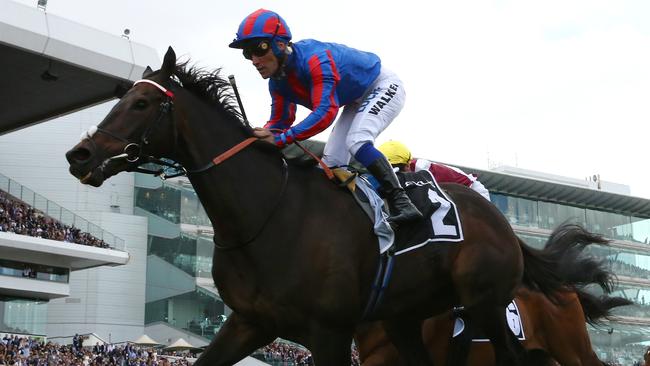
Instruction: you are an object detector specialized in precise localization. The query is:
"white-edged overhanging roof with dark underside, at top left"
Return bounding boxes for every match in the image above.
[0,0,160,134]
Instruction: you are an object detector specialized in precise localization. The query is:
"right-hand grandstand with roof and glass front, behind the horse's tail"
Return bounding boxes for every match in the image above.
[461,167,650,365]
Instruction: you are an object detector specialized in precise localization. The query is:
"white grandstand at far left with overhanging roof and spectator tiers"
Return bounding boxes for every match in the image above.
[0,0,159,348]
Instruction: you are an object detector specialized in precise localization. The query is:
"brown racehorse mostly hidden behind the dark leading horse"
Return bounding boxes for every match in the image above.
[355,225,632,366]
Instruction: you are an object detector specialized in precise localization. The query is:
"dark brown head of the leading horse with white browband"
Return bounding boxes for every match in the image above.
[66,47,176,187]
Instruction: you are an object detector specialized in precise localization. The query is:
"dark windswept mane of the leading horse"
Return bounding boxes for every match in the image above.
[168,60,252,132]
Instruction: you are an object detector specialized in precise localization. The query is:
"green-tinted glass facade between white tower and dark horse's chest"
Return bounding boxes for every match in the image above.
[135,177,226,338]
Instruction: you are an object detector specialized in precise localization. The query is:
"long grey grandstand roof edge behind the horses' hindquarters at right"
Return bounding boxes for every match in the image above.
[459,167,650,218]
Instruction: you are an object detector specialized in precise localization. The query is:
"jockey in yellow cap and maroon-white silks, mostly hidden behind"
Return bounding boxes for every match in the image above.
[379,141,490,201]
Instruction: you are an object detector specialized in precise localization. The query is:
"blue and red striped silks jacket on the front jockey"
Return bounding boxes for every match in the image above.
[264,39,381,145]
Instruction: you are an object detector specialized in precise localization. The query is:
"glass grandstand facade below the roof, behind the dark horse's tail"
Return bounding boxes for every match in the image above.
[490,193,650,365]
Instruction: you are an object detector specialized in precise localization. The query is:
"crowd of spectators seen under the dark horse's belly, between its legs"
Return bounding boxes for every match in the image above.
[253,341,361,366]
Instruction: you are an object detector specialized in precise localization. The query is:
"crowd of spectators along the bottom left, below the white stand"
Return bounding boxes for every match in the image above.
[0,335,190,366]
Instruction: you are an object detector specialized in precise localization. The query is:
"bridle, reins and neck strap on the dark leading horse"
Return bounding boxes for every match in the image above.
[81,79,289,250]
